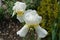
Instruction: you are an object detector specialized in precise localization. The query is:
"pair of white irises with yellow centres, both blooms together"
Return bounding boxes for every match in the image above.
[13,2,48,38]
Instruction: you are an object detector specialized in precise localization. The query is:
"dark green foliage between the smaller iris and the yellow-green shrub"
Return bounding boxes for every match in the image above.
[23,0,40,10]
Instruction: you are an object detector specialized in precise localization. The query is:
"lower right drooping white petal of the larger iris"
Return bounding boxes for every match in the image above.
[35,26,48,38]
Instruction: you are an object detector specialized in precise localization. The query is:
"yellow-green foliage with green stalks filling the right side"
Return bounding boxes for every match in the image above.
[37,0,58,40]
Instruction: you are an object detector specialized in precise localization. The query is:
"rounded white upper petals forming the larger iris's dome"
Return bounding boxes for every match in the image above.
[24,10,42,24]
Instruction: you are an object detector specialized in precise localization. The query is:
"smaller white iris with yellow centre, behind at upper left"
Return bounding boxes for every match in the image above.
[12,2,26,22]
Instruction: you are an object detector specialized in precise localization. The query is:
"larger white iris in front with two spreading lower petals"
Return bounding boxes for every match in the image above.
[17,10,48,38]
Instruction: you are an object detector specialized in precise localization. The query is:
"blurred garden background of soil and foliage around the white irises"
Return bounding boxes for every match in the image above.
[0,0,60,40]
